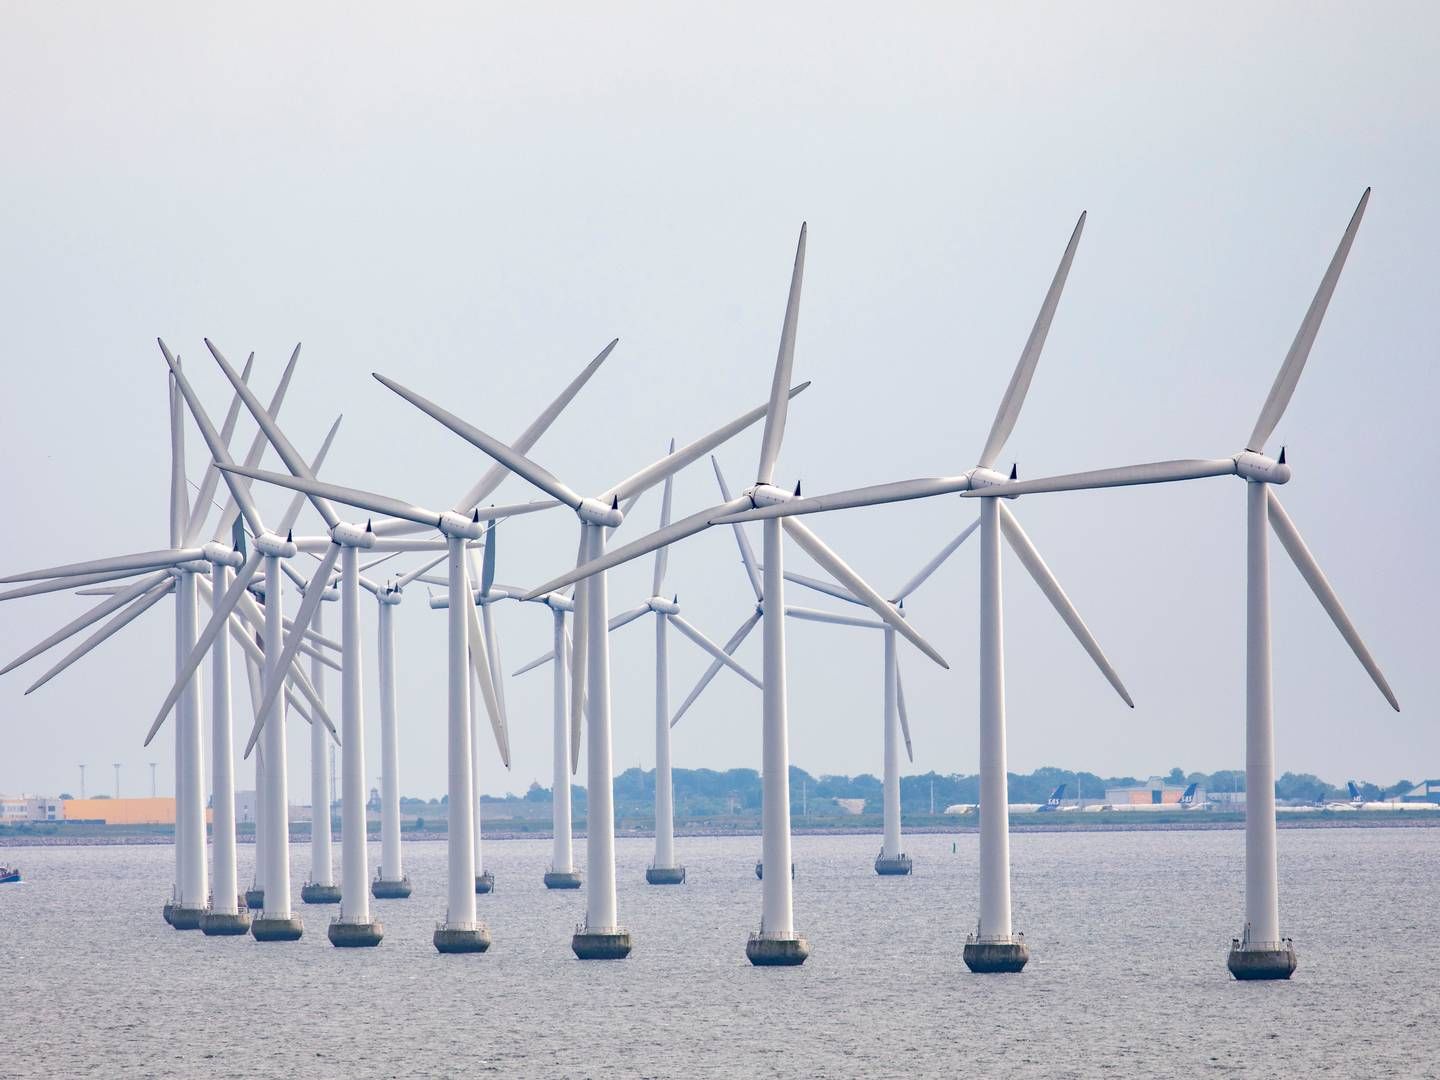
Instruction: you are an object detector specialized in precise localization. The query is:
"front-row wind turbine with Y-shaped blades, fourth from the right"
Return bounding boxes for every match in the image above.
[365,364,805,959]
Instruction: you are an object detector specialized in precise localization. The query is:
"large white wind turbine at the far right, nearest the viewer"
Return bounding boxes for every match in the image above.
[976,187,1400,979]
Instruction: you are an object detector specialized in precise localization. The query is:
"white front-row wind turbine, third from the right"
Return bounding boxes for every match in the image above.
[526,225,948,966]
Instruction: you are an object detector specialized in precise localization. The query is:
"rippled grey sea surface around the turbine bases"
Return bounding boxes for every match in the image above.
[0,828,1440,1080]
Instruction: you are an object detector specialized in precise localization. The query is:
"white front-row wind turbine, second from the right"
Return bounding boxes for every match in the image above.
[604,213,1133,972]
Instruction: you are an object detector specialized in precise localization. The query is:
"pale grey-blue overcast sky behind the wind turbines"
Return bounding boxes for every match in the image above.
[0,1,1440,802]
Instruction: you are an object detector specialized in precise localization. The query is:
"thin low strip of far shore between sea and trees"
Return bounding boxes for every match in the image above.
[0,811,1440,850]
